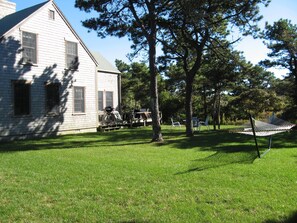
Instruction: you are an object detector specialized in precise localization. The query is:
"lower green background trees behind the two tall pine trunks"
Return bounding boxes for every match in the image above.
[116,42,296,128]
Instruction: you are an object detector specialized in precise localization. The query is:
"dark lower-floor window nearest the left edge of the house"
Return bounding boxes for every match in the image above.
[13,81,31,115]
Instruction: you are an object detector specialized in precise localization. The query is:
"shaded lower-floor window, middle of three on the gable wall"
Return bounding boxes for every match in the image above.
[45,83,60,115]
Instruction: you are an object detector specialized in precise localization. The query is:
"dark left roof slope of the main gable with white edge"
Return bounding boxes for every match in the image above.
[0,2,48,37]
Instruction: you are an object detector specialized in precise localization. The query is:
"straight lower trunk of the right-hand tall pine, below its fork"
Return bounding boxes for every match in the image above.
[185,74,194,137]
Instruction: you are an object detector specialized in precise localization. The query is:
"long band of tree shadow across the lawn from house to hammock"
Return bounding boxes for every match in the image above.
[0,127,296,159]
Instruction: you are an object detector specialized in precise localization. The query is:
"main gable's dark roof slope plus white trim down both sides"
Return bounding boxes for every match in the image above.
[0,0,98,65]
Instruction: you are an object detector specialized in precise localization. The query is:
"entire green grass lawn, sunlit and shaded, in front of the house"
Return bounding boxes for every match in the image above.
[0,126,297,223]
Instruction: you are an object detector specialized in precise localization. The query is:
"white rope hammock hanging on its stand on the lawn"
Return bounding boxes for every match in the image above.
[237,115,295,158]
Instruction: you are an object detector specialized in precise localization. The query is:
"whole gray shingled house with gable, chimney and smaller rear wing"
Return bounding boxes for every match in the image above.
[0,0,120,141]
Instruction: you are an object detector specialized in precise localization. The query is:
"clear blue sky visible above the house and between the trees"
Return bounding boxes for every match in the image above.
[10,0,297,77]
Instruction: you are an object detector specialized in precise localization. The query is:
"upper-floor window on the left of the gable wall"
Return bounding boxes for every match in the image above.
[22,32,37,64]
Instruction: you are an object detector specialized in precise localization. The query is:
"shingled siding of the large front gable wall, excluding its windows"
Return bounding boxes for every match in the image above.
[0,3,97,140]
